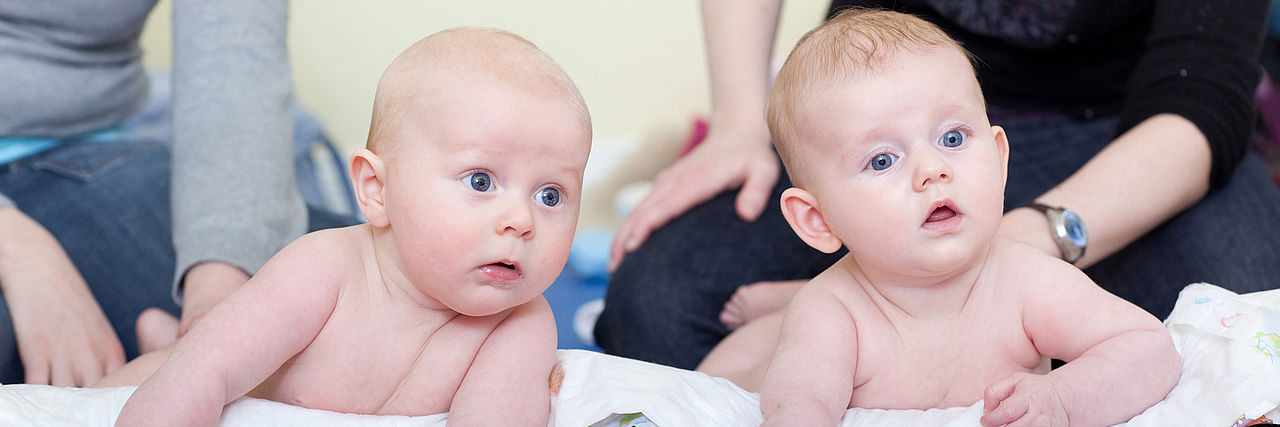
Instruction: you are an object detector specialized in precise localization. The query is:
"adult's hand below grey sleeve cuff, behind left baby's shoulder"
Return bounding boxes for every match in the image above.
[178,261,248,336]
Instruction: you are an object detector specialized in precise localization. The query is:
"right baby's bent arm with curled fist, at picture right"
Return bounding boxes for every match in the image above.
[982,260,1181,426]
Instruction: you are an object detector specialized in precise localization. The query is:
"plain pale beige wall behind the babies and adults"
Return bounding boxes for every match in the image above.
[135,0,827,230]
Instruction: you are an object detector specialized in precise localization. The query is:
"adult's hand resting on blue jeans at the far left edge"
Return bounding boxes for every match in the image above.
[0,207,124,386]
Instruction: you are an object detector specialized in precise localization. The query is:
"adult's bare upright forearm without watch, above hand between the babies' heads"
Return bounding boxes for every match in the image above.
[701,0,782,136]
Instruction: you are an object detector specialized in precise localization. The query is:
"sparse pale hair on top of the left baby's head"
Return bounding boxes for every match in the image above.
[366,27,591,153]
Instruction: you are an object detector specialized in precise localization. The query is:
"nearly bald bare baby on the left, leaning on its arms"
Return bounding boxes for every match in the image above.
[110,28,591,427]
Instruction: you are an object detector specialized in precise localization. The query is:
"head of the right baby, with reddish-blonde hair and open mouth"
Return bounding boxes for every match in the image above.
[767,9,1009,274]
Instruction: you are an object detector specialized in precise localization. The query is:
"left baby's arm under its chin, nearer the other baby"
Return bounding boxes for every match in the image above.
[449,297,556,427]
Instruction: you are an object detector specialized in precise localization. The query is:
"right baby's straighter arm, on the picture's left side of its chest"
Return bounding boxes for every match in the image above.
[760,283,858,426]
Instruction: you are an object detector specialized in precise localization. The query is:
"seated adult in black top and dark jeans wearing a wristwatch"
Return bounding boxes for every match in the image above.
[595,0,1280,368]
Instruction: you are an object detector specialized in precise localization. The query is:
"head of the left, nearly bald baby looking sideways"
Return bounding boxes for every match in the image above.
[351,28,591,316]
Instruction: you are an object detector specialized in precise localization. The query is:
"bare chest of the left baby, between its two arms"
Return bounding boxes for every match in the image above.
[247,315,489,415]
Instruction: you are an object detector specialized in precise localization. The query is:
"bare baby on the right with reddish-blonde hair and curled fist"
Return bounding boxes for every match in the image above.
[700,9,1180,426]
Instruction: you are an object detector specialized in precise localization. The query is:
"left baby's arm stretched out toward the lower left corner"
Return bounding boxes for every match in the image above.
[116,237,342,426]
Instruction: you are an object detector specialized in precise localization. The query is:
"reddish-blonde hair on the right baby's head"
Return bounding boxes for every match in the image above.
[765,8,973,185]
